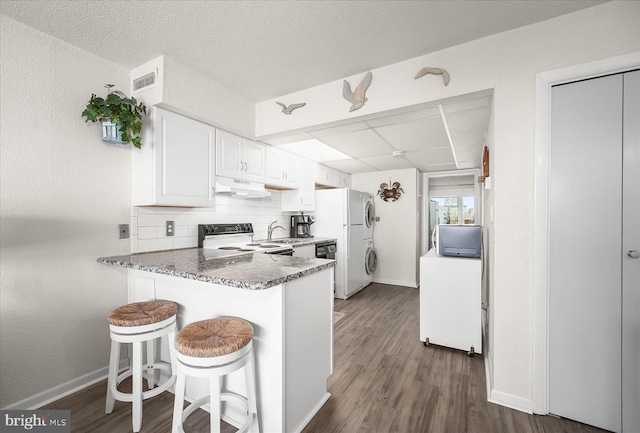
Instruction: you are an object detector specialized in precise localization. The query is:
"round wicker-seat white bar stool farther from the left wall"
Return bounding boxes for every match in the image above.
[172,317,260,433]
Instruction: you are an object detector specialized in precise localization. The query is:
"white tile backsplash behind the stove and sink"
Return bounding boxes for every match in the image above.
[131,191,291,253]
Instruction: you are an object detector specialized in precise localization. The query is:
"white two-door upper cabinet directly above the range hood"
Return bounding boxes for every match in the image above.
[216,129,265,183]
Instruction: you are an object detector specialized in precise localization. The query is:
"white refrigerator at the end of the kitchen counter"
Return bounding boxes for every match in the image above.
[313,188,366,299]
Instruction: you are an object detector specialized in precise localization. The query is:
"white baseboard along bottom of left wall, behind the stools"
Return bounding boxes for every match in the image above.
[2,359,129,410]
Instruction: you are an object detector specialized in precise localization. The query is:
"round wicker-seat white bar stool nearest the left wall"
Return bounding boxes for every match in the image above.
[105,300,178,432]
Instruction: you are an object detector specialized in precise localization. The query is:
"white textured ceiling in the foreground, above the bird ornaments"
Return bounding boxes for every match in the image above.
[0,0,603,102]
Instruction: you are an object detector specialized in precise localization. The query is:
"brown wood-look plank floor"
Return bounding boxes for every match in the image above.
[44,283,604,433]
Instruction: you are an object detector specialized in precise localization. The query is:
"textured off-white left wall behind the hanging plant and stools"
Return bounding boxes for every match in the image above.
[0,16,131,407]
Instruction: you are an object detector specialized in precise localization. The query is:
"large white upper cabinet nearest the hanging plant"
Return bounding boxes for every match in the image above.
[131,107,216,207]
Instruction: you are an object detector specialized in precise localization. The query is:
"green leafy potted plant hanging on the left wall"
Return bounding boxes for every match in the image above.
[82,84,147,149]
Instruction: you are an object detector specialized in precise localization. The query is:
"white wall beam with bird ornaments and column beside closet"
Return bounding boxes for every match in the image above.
[256,1,640,411]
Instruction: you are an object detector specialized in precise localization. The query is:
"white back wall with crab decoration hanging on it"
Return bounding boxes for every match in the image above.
[351,168,420,287]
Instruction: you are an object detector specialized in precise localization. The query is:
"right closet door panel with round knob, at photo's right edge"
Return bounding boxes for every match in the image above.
[622,71,640,433]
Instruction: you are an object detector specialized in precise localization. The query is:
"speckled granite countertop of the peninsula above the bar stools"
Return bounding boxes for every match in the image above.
[98,248,335,290]
